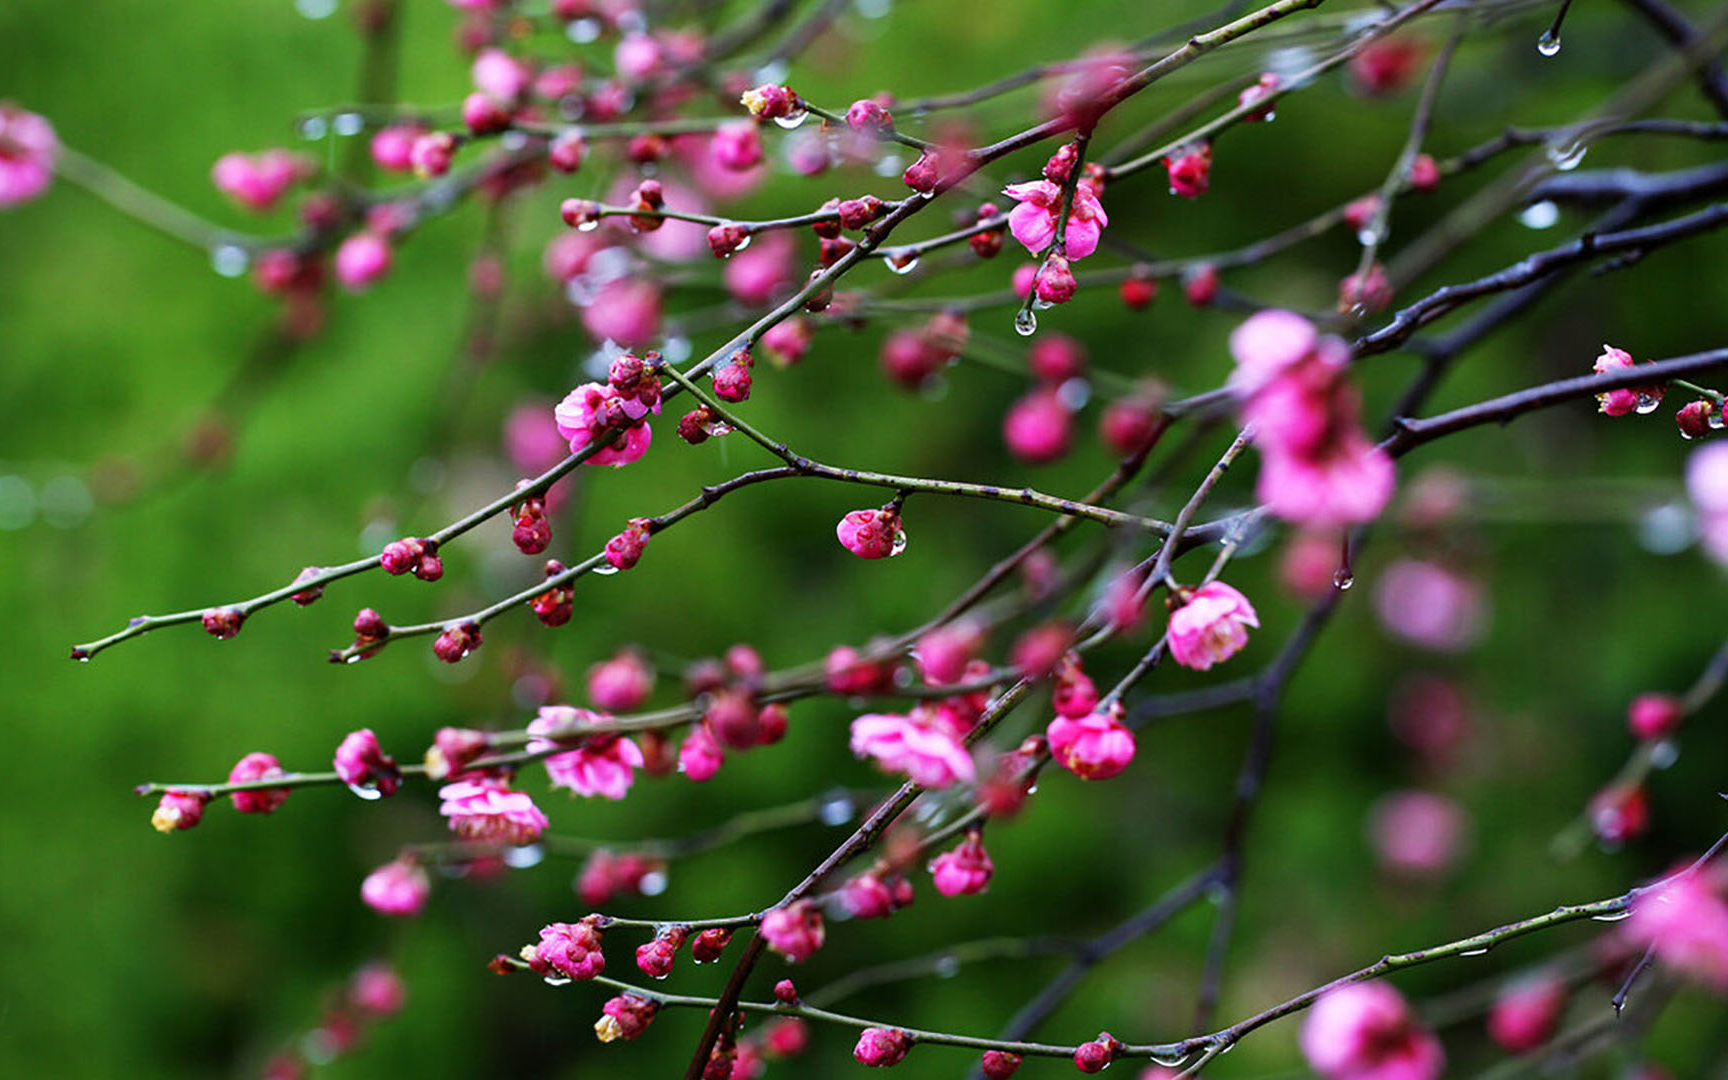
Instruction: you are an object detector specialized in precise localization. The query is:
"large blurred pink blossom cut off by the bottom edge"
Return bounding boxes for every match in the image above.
[1301,983,1446,1080]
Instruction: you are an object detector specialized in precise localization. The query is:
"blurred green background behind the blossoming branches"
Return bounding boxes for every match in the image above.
[0,0,1728,1080]
